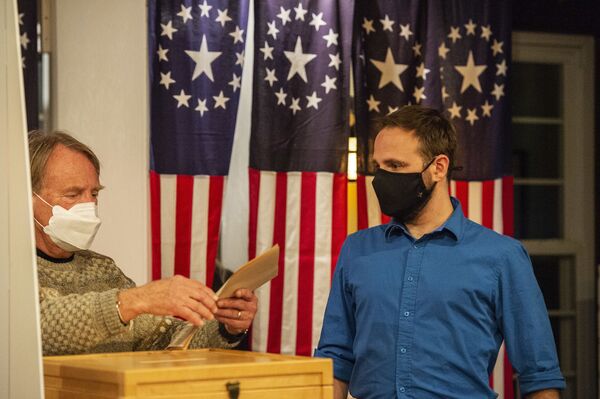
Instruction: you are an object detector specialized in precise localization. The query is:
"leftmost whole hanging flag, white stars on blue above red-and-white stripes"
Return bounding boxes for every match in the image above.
[148,0,249,287]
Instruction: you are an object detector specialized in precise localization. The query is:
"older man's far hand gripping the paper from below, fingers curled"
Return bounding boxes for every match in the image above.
[215,288,258,335]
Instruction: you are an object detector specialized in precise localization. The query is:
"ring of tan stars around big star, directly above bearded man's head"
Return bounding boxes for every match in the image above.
[360,9,439,117]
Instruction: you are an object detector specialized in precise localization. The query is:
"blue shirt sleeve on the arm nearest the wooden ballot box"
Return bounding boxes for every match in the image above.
[314,241,355,382]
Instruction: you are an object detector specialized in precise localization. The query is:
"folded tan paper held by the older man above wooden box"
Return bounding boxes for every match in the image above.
[167,245,279,350]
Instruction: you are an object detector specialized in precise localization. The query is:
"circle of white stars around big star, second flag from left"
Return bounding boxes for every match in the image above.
[256,1,342,119]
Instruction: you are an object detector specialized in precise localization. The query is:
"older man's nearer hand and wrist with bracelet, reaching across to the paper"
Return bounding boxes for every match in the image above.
[119,276,218,326]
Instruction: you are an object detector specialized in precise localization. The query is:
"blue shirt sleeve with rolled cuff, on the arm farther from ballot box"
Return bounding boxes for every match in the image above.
[496,241,565,394]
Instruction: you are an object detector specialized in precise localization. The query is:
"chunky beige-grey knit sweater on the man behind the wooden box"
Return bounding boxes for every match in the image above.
[37,251,238,355]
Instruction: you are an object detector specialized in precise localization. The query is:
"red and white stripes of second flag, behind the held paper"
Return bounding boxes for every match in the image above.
[248,169,347,355]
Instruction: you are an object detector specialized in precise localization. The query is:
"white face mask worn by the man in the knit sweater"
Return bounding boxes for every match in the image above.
[34,193,102,252]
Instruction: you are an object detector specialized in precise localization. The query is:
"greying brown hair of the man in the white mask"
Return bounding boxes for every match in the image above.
[28,130,100,192]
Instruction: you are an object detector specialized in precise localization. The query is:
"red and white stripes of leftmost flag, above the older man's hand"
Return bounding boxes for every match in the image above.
[150,171,225,287]
